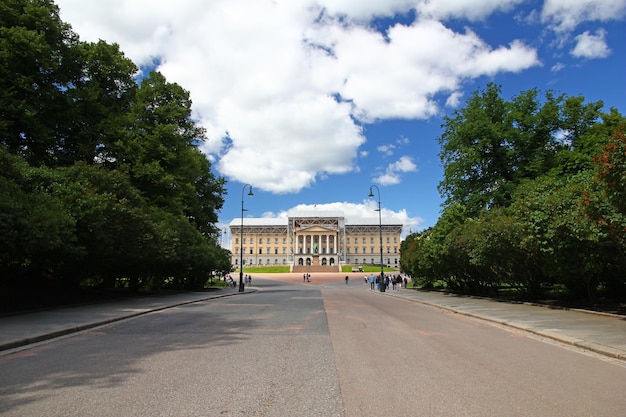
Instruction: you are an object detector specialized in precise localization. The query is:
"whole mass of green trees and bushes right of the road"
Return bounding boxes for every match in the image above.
[401,84,626,300]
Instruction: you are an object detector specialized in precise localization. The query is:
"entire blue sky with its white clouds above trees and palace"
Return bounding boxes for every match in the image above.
[57,0,626,244]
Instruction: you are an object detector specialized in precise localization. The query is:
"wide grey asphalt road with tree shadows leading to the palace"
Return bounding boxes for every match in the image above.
[0,278,626,417]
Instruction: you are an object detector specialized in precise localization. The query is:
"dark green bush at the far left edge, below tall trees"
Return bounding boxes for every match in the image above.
[0,146,83,301]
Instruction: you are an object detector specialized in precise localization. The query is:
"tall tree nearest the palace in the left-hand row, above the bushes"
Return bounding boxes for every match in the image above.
[111,72,224,218]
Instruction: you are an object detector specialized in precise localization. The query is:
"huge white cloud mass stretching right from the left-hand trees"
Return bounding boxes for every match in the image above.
[57,0,539,193]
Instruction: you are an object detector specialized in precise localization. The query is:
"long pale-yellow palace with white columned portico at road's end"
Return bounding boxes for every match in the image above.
[230,211,402,271]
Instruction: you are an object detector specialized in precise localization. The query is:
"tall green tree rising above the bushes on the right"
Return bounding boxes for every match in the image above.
[439,83,602,215]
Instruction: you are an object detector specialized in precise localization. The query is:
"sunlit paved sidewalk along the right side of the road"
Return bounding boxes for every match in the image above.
[381,289,626,361]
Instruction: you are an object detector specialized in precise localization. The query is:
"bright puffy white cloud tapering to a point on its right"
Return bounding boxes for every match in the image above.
[312,20,539,122]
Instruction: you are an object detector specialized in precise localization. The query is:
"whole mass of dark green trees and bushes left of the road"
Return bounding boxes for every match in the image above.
[0,0,230,302]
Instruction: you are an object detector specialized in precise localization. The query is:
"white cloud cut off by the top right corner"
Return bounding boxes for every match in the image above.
[541,0,626,32]
